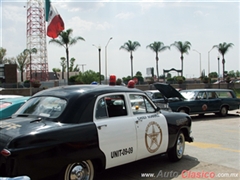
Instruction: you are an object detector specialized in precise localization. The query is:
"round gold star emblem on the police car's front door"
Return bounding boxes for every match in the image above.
[145,121,162,153]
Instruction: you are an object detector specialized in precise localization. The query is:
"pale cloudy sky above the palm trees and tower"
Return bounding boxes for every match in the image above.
[0,0,240,78]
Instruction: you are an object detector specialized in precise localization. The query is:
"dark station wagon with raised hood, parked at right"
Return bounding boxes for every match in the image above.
[154,83,240,116]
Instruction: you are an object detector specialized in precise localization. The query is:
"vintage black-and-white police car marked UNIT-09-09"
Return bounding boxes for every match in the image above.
[0,85,193,180]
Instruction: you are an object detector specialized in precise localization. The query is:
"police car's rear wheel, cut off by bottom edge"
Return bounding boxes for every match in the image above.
[64,160,94,180]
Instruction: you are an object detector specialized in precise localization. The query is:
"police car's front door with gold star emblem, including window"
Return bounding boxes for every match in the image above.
[128,93,168,159]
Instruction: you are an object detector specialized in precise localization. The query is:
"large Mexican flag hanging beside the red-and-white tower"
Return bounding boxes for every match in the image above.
[45,0,64,39]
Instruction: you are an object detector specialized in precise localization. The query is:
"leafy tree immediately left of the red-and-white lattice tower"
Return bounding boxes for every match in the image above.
[15,51,29,82]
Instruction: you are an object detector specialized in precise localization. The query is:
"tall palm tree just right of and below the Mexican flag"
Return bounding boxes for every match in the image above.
[49,29,85,84]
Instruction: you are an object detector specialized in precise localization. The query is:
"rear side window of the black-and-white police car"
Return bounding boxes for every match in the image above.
[95,95,127,119]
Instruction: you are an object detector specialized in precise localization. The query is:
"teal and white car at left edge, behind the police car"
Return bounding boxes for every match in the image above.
[0,96,31,120]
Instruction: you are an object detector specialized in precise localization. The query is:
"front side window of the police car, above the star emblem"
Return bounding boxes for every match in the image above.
[129,94,155,114]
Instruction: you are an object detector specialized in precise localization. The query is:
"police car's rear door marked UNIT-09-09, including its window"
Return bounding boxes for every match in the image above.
[94,93,137,168]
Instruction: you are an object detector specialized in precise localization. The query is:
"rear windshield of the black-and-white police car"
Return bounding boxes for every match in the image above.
[15,96,67,118]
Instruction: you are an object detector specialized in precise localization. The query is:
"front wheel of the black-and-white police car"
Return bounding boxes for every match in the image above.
[168,131,185,161]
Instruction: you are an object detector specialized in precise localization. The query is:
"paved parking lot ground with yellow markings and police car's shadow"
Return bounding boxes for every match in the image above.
[95,111,240,180]
